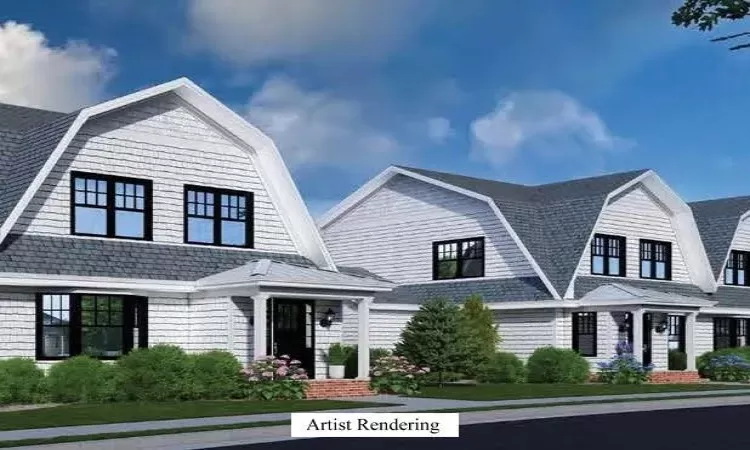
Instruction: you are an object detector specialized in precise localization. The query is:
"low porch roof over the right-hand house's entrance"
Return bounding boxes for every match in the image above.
[579,283,716,308]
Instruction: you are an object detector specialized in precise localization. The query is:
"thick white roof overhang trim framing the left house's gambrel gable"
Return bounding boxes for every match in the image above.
[0,78,336,270]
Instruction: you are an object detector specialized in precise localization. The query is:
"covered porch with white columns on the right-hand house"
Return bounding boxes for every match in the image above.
[577,283,716,372]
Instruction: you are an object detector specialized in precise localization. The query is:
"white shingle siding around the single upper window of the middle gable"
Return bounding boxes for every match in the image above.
[323,175,536,283]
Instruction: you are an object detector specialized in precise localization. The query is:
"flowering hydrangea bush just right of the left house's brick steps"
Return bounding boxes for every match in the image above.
[370,356,430,395]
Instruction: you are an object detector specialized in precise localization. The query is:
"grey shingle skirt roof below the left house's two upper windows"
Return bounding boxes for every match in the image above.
[0,234,314,281]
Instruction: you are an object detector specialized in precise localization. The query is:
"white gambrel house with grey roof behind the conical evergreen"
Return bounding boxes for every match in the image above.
[320,167,750,371]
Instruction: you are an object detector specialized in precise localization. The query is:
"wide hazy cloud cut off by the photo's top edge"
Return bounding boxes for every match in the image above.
[187,0,432,65]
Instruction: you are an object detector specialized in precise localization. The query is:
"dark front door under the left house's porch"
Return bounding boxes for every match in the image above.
[268,298,315,378]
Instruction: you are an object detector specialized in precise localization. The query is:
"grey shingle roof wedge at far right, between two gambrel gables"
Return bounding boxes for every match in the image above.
[689,196,750,278]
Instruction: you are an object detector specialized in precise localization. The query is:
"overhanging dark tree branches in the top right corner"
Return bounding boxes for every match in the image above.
[672,0,750,50]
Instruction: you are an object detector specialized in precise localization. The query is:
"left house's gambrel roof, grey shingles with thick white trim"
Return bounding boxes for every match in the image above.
[0,78,336,278]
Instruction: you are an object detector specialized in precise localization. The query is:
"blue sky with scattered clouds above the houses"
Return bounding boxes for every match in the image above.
[0,0,750,216]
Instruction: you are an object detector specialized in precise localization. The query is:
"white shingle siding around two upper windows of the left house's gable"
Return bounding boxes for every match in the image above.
[15,92,295,252]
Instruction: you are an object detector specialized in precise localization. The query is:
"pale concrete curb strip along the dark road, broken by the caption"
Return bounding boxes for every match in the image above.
[16,395,750,450]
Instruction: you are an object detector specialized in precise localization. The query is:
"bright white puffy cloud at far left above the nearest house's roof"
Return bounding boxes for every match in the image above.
[0,22,116,111]
